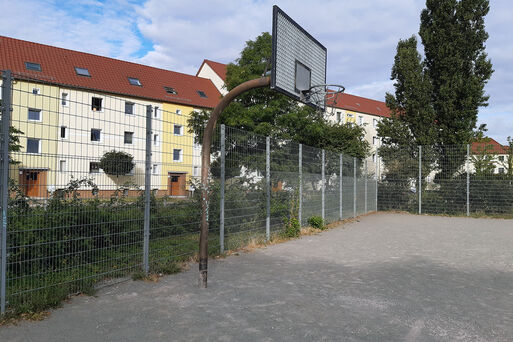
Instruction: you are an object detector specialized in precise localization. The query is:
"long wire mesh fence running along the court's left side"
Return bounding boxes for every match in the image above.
[0,73,377,312]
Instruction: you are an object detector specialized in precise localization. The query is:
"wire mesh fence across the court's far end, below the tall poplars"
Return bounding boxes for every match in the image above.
[378,144,513,218]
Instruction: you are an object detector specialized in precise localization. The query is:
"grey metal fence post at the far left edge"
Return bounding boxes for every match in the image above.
[0,70,12,315]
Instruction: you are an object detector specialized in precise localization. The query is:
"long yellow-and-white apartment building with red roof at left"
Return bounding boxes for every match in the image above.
[0,36,221,198]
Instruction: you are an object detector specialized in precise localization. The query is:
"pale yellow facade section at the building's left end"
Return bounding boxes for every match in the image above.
[11,80,59,190]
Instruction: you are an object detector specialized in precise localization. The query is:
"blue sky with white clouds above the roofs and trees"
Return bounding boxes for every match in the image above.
[0,0,513,143]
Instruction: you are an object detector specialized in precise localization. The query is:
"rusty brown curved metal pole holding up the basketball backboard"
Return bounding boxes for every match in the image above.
[199,77,271,288]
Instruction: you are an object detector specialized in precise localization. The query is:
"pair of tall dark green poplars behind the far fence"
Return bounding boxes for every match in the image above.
[378,0,493,178]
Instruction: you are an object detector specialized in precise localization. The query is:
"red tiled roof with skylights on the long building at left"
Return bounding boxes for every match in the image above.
[0,36,221,108]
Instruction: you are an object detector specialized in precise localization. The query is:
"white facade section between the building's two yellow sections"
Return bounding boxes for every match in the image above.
[56,88,162,190]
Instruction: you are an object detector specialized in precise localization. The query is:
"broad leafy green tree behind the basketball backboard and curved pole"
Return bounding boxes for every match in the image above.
[188,32,369,178]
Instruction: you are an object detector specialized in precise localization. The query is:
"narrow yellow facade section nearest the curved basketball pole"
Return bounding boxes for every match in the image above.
[157,103,194,195]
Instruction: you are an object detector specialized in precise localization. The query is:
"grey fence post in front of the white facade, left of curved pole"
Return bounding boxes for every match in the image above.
[143,105,153,274]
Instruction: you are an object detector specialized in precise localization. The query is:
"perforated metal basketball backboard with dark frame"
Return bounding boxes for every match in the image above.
[271,5,328,109]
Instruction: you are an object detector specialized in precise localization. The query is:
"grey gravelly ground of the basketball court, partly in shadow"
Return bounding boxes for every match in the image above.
[0,213,513,342]
